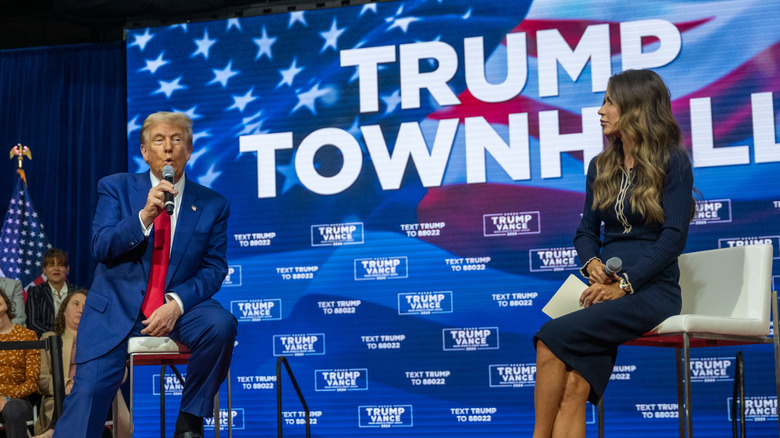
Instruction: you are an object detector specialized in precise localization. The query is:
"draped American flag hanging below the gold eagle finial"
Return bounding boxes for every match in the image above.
[0,176,51,290]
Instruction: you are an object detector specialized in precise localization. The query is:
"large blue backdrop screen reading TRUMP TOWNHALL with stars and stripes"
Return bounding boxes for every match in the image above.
[127,0,780,437]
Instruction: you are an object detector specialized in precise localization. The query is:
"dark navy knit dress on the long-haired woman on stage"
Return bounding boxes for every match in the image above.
[534,148,693,404]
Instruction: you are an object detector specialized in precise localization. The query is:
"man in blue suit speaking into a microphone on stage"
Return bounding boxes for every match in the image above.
[54,112,237,438]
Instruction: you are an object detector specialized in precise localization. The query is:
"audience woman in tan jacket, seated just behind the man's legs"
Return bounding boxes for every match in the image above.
[35,289,126,438]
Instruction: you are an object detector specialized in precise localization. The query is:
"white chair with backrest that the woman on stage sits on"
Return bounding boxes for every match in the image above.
[598,245,780,437]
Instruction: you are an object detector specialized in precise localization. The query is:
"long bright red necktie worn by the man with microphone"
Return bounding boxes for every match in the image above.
[141,212,171,318]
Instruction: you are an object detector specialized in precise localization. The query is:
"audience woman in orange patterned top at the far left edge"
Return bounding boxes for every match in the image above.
[0,282,41,438]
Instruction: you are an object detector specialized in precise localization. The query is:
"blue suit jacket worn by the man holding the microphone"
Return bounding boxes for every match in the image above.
[76,172,230,362]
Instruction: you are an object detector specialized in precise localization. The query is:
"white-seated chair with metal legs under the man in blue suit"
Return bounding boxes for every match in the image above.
[114,336,233,438]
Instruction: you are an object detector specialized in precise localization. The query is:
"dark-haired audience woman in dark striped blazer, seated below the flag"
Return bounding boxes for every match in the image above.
[25,248,78,336]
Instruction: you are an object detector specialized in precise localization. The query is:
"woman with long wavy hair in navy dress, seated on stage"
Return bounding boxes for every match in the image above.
[534,70,695,438]
